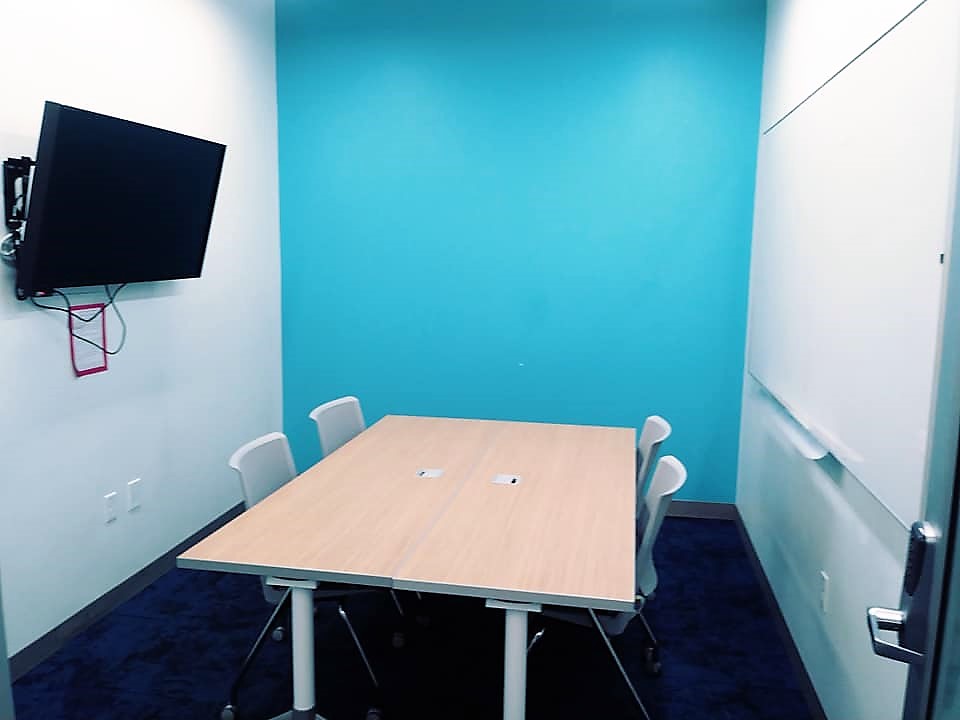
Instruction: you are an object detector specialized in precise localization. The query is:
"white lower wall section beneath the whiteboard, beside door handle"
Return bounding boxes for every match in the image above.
[737,376,906,720]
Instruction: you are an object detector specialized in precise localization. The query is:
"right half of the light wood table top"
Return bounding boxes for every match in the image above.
[394,423,636,610]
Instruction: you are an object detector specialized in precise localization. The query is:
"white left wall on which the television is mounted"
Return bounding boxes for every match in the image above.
[0,0,281,654]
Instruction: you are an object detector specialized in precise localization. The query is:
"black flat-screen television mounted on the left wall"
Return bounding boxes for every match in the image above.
[17,102,226,297]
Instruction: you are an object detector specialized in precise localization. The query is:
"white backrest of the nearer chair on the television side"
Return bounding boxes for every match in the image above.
[229,432,297,605]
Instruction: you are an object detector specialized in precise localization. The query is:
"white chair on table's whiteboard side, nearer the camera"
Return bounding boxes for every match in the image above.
[527,455,687,720]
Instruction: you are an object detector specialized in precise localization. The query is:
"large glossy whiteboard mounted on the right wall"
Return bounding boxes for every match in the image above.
[747,0,960,523]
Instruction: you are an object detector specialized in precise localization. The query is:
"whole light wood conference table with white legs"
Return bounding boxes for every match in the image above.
[177,415,636,720]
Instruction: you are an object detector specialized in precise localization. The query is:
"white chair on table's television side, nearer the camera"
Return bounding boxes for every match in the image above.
[220,432,379,720]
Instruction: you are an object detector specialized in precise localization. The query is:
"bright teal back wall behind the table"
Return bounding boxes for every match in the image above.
[277,0,764,502]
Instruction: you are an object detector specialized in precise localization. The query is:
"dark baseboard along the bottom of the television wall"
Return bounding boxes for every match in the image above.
[10,503,243,681]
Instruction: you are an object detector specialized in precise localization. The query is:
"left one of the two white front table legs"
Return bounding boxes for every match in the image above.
[267,578,323,720]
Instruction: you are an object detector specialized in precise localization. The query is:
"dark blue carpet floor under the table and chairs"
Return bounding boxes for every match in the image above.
[14,518,811,720]
